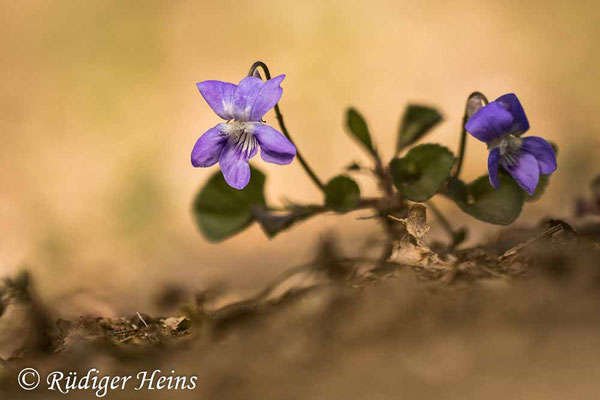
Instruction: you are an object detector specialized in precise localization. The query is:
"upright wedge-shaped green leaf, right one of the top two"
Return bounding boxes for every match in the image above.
[396,104,443,153]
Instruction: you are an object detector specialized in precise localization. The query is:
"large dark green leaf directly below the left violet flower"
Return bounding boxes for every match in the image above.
[193,167,266,242]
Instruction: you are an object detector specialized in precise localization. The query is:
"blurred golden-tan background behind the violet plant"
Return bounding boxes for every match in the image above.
[0,0,600,316]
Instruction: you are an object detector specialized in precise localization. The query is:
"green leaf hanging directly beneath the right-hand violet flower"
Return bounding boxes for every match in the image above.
[446,173,525,225]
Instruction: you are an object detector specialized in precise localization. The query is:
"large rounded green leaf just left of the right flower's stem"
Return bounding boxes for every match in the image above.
[390,144,454,202]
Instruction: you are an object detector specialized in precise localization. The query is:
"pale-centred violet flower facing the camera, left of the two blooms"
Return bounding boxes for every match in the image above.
[192,75,296,190]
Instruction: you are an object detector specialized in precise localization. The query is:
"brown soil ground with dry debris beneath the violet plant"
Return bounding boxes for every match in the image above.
[0,216,600,400]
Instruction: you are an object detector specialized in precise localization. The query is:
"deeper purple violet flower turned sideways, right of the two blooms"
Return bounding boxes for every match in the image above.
[465,93,556,195]
